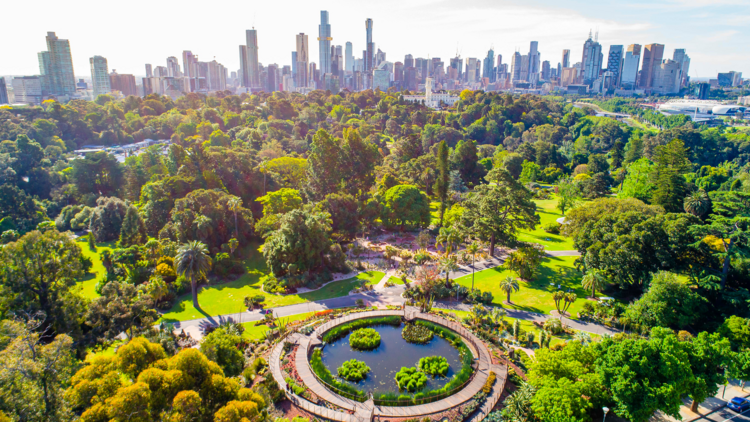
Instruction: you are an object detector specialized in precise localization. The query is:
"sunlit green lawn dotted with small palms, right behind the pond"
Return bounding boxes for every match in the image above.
[456,256,587,315]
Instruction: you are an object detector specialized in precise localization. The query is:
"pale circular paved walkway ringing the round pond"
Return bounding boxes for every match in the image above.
[270,307,507,422]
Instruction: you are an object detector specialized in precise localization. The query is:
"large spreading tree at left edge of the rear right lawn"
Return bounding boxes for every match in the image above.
[458,168,539,255]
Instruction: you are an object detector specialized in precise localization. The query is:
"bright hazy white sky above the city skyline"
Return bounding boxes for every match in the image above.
[0,0,750,78]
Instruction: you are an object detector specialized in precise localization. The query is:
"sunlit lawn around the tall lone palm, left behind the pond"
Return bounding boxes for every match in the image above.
[162,244,385,322]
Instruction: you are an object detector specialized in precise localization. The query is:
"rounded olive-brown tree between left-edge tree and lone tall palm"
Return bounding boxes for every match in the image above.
[86,280,158,340]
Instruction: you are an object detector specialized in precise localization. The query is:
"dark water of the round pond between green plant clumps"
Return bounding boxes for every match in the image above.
[321,324,468,394]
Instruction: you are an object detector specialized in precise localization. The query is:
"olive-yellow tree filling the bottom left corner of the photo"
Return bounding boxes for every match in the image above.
[0,314,76,422]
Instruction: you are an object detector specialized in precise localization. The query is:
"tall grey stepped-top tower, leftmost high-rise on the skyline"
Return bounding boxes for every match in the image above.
[38,32,76,95]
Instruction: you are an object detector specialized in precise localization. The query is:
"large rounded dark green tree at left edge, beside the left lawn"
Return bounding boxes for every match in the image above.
[0,230,86,341]
